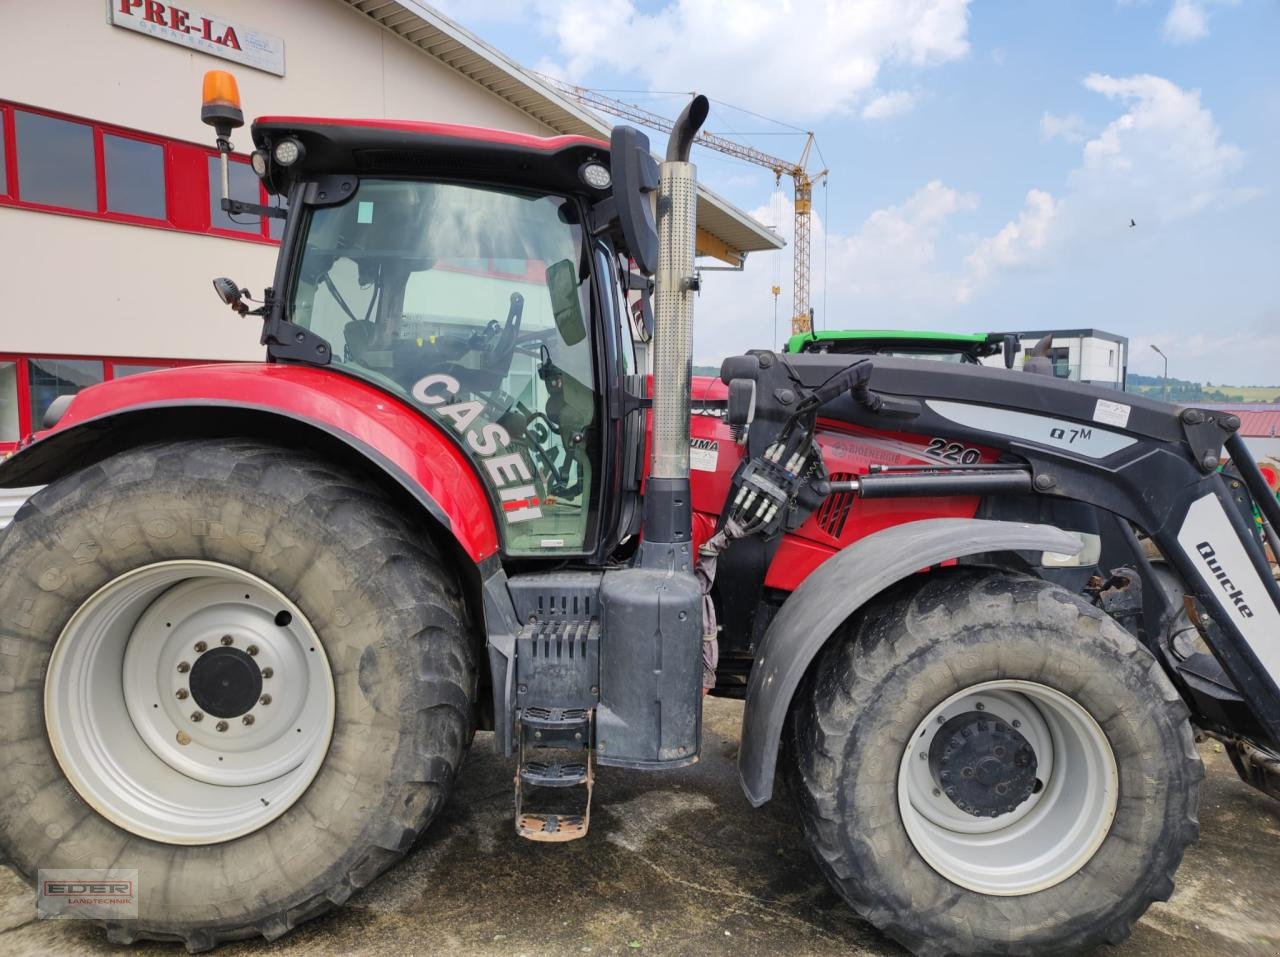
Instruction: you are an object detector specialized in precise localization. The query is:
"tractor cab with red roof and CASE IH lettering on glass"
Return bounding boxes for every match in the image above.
[212,116,653,558]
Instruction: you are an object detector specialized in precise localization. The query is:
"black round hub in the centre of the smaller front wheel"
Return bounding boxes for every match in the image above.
[929,711,1038,818]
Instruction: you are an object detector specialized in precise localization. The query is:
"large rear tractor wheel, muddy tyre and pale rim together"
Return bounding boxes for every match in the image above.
[0,439,476,953]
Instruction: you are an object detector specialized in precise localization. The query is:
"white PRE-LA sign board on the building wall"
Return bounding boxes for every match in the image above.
[109,0,284,77]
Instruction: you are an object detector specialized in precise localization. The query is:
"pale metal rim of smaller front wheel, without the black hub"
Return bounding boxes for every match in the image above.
[897,679,1120,897]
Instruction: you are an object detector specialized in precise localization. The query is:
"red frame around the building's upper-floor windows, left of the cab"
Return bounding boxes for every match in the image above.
[0,100,279,246]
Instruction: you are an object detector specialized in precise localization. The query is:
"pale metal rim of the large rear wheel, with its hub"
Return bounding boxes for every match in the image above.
[45,562,337,844]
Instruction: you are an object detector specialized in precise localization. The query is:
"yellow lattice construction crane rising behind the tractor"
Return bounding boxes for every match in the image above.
[536,73,828,335]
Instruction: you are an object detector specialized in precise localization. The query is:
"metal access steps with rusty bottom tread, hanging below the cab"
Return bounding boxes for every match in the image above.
[516,706,595,842]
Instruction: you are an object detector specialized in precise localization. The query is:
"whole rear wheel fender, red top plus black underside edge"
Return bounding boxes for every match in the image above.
[0,362,499,564]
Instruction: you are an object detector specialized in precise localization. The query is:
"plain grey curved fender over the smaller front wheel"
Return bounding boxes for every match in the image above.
[737,518,1080,807]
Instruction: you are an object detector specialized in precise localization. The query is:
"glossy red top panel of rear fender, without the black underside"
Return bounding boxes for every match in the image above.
[30,363,498,562]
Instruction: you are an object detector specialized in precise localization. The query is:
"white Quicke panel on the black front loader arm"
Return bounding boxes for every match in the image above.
[1178,494,1280,684]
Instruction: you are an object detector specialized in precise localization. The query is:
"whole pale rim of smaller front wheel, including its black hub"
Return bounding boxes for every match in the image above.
[897,678,1119,897]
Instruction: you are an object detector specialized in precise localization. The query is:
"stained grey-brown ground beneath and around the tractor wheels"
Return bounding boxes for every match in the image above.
[0,699,1280,957]
